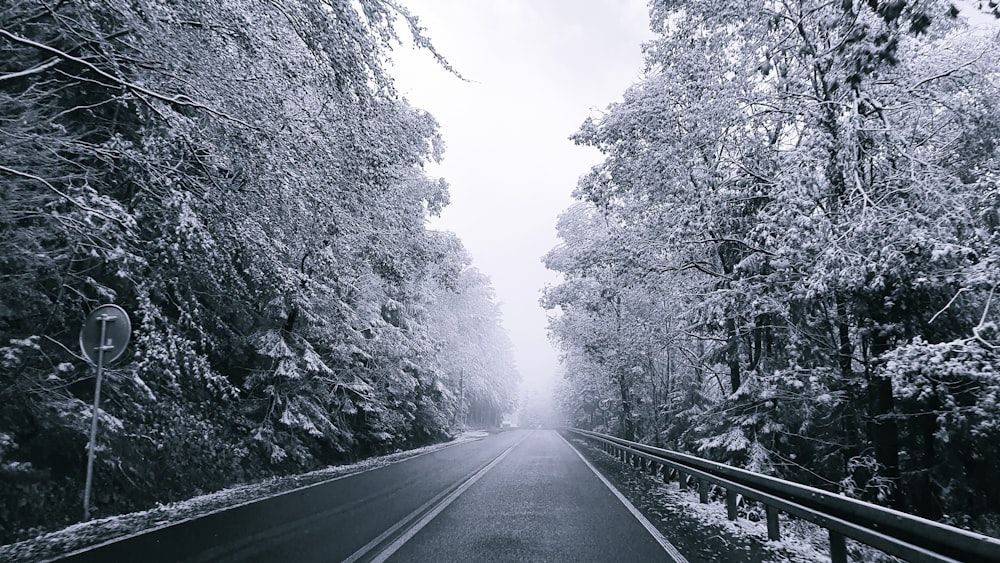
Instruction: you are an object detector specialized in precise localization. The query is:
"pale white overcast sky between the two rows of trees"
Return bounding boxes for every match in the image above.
[393,0,652,387]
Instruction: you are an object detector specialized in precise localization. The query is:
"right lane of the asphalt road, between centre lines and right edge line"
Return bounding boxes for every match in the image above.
[389,430,672,563]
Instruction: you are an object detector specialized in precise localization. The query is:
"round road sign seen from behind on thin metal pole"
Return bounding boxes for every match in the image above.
[80,305,132,520]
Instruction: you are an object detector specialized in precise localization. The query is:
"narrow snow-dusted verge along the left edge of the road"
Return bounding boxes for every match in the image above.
[0,430,489,562]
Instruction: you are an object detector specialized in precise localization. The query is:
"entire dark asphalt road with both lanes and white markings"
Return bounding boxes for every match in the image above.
[54,430,682,563]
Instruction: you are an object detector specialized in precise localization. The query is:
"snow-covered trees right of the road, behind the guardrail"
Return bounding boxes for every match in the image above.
[542,0,1000,536]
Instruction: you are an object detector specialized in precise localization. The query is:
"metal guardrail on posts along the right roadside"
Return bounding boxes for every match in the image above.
[566,428,1000,563]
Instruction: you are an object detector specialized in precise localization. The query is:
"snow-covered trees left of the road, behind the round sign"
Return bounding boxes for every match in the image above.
[0,0,519,543]
